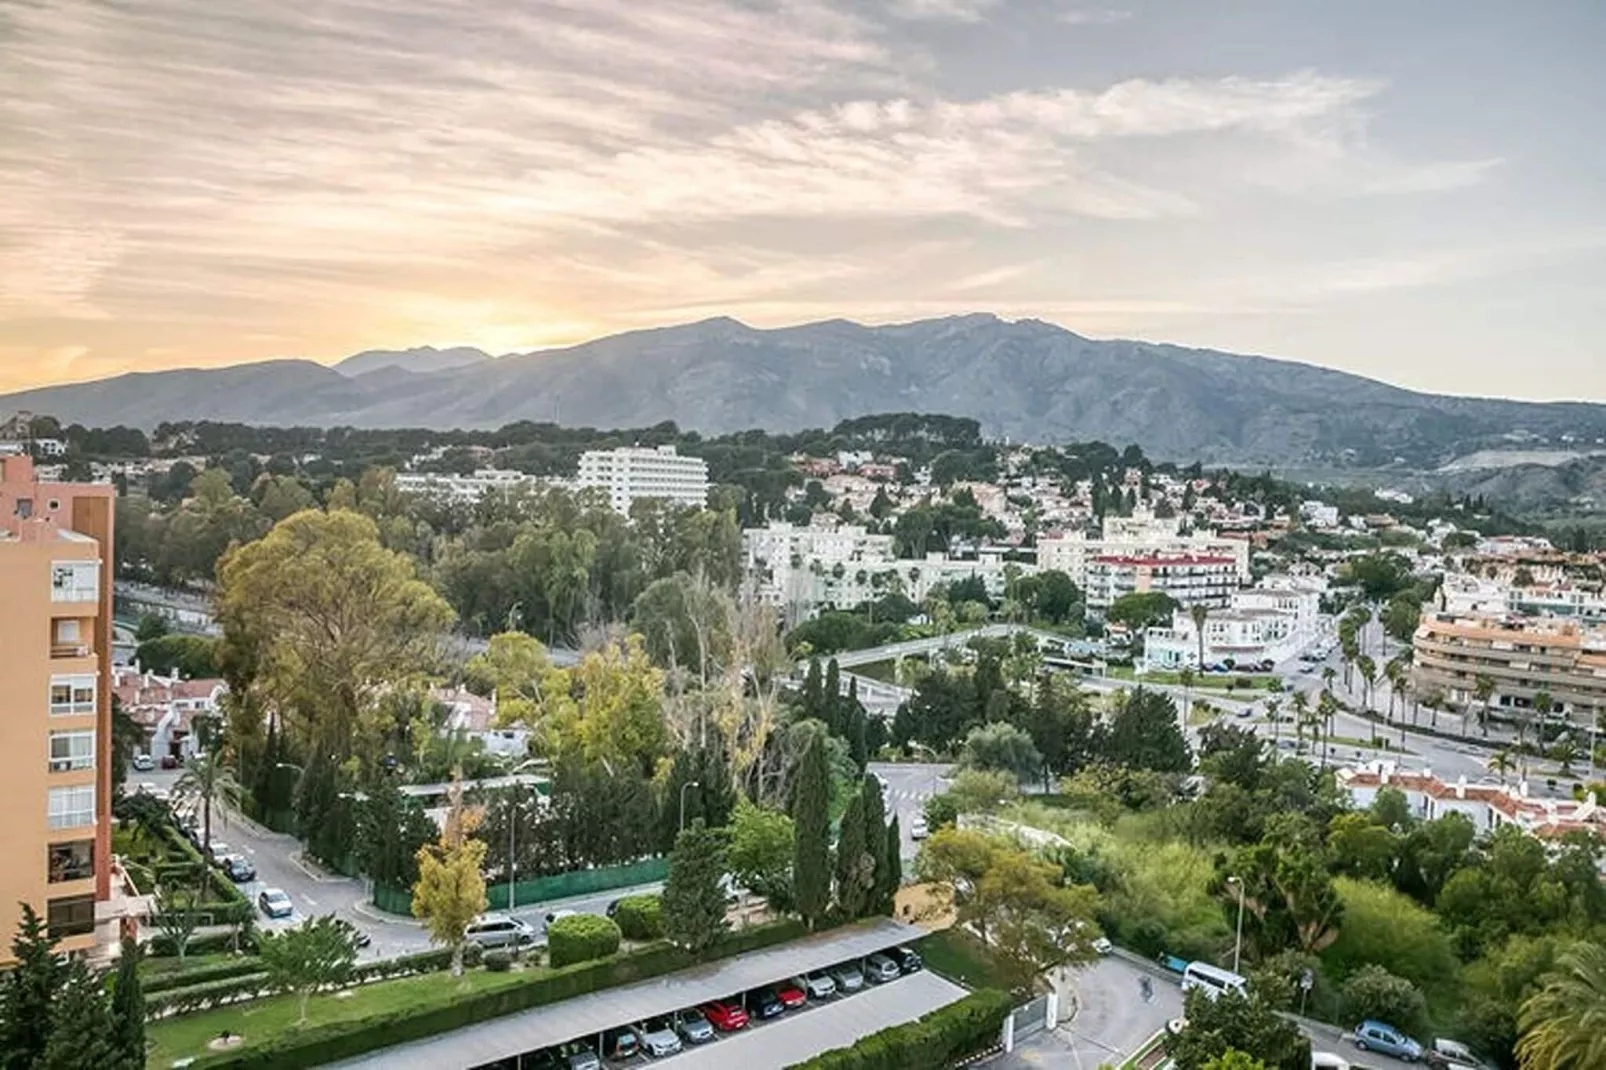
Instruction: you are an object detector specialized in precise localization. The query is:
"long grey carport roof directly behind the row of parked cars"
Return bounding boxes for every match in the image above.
[334,917,925,1070]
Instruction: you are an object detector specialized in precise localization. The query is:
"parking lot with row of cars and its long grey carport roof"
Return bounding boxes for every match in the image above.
[324,919,931,1070]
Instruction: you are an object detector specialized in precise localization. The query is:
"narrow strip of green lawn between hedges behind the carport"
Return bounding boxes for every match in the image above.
[146,969,527,1070]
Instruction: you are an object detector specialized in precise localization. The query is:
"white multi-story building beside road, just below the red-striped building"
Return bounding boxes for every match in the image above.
[1143,577,1325,672]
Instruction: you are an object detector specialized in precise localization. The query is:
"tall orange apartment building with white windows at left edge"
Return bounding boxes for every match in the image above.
[0,456,142,962]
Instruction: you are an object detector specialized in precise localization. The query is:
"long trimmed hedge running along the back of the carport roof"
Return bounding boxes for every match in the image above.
[182,919,808,1070]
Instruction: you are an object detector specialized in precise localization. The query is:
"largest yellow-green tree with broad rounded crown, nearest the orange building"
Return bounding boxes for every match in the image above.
[217,509,453,762]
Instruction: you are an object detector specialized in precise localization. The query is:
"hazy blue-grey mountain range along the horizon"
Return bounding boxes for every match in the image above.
[0,313,1606,466]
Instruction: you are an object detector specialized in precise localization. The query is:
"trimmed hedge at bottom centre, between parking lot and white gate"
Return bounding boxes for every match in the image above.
[787,988,1015,1070]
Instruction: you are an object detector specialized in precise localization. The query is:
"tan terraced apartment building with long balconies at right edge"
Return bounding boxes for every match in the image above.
[1412,614,1606,725]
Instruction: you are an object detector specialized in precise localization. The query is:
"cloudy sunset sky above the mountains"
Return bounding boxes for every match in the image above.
[0,0,1606,400]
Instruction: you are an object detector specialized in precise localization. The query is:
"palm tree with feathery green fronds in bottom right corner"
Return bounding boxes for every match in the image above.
[1516,943,1606,1070]
